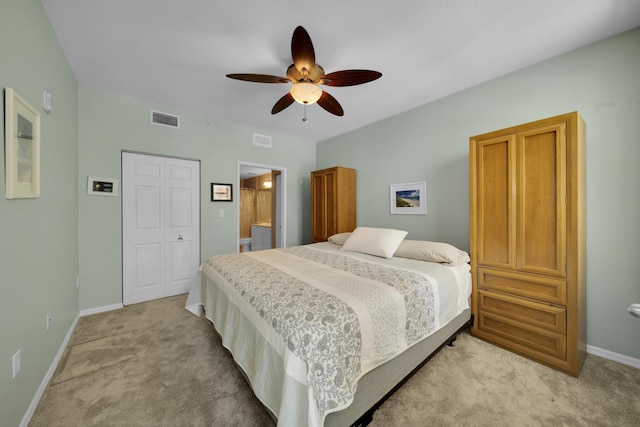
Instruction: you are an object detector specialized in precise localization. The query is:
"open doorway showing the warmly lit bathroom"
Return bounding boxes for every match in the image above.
[237,162,286,252]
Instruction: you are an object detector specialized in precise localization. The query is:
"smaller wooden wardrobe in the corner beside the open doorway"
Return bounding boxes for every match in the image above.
[311,166,356,243]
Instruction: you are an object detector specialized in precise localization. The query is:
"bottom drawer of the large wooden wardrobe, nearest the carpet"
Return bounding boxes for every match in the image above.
[478,310,567,360]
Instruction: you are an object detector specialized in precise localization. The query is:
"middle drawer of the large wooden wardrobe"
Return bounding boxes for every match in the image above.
[478,290,567,335]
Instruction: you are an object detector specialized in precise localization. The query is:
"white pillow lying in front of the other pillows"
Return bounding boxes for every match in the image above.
[340,227,407,258]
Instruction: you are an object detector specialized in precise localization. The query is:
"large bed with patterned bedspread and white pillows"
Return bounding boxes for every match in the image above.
[187,227,471,427]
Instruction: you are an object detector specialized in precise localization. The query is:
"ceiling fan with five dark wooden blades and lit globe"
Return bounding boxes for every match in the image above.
[227,26,382,118]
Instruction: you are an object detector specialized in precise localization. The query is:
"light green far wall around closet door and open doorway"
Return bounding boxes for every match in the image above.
[78,88,315,309]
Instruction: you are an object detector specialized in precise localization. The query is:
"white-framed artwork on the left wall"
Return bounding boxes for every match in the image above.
[4,88,40,199]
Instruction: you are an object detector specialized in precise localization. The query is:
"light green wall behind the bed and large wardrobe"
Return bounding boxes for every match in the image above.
[316,29,640,358]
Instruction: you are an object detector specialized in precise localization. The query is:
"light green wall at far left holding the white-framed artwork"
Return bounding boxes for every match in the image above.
[0,0,78,426]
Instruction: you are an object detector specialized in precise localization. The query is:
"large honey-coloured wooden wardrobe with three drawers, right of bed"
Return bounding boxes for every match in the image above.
[469,112,586,376]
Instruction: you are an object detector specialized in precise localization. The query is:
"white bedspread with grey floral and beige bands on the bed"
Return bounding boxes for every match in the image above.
[187,243,470,426]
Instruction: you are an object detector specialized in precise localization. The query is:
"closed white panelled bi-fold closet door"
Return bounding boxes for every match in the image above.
[122,152,200,305]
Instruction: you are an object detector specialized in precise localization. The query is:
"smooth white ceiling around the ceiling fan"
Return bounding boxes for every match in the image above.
[42,0,640,142]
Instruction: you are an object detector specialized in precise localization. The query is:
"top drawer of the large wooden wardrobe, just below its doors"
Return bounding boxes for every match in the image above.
[478,267,567,305]
